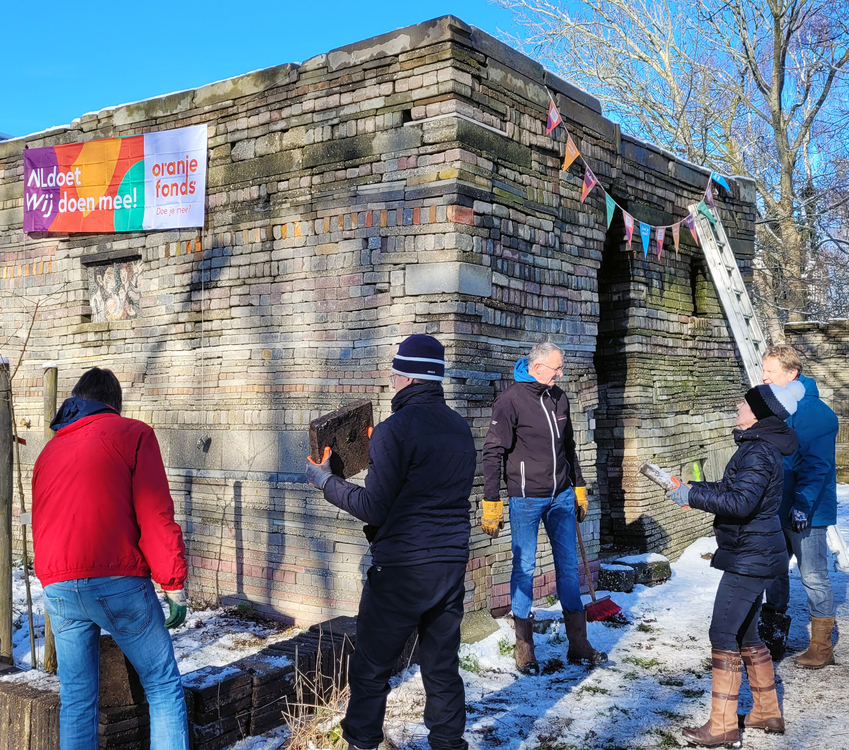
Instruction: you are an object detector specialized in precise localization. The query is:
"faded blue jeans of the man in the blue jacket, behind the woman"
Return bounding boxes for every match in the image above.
[766,526,834,617]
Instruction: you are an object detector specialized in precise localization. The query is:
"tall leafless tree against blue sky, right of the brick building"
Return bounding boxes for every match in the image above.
[499,0,849,341]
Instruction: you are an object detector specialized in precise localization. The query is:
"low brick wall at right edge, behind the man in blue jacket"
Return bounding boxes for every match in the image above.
[784,320,849,482]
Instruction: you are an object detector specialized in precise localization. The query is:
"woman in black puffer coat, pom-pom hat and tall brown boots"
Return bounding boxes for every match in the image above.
[669,381,804,747]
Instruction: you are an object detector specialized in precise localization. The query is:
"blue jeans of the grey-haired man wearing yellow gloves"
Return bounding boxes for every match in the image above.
[510,487,584,618]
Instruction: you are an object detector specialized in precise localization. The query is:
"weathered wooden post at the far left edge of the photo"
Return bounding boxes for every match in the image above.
[0,356,14,666]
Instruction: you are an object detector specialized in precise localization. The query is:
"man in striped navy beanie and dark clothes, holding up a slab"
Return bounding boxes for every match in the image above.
[307,334,477,750]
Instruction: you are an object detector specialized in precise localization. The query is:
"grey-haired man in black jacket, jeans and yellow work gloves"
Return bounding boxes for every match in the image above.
[482,342,607,674]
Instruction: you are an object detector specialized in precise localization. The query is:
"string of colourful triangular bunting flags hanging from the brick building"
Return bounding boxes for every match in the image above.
[545,91,731,260]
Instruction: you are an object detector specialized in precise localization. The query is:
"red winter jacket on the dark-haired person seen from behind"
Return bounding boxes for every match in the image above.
[32,413,186,591]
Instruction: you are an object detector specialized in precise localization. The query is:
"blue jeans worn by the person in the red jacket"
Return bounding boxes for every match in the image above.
[44,576,189,750]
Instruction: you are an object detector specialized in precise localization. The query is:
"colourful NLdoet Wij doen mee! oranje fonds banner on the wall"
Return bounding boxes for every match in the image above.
[24,125,207,233]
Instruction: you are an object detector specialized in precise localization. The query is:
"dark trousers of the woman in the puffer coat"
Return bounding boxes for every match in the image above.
[710,571,772,651]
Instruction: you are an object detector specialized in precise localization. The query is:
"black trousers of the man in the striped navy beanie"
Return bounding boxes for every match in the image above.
[342,562,468,750]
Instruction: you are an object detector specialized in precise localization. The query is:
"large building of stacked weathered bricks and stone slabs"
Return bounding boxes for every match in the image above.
[0,17,754,622]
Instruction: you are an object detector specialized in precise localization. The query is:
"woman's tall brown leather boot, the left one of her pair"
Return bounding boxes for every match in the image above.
[682,648,743,747]
